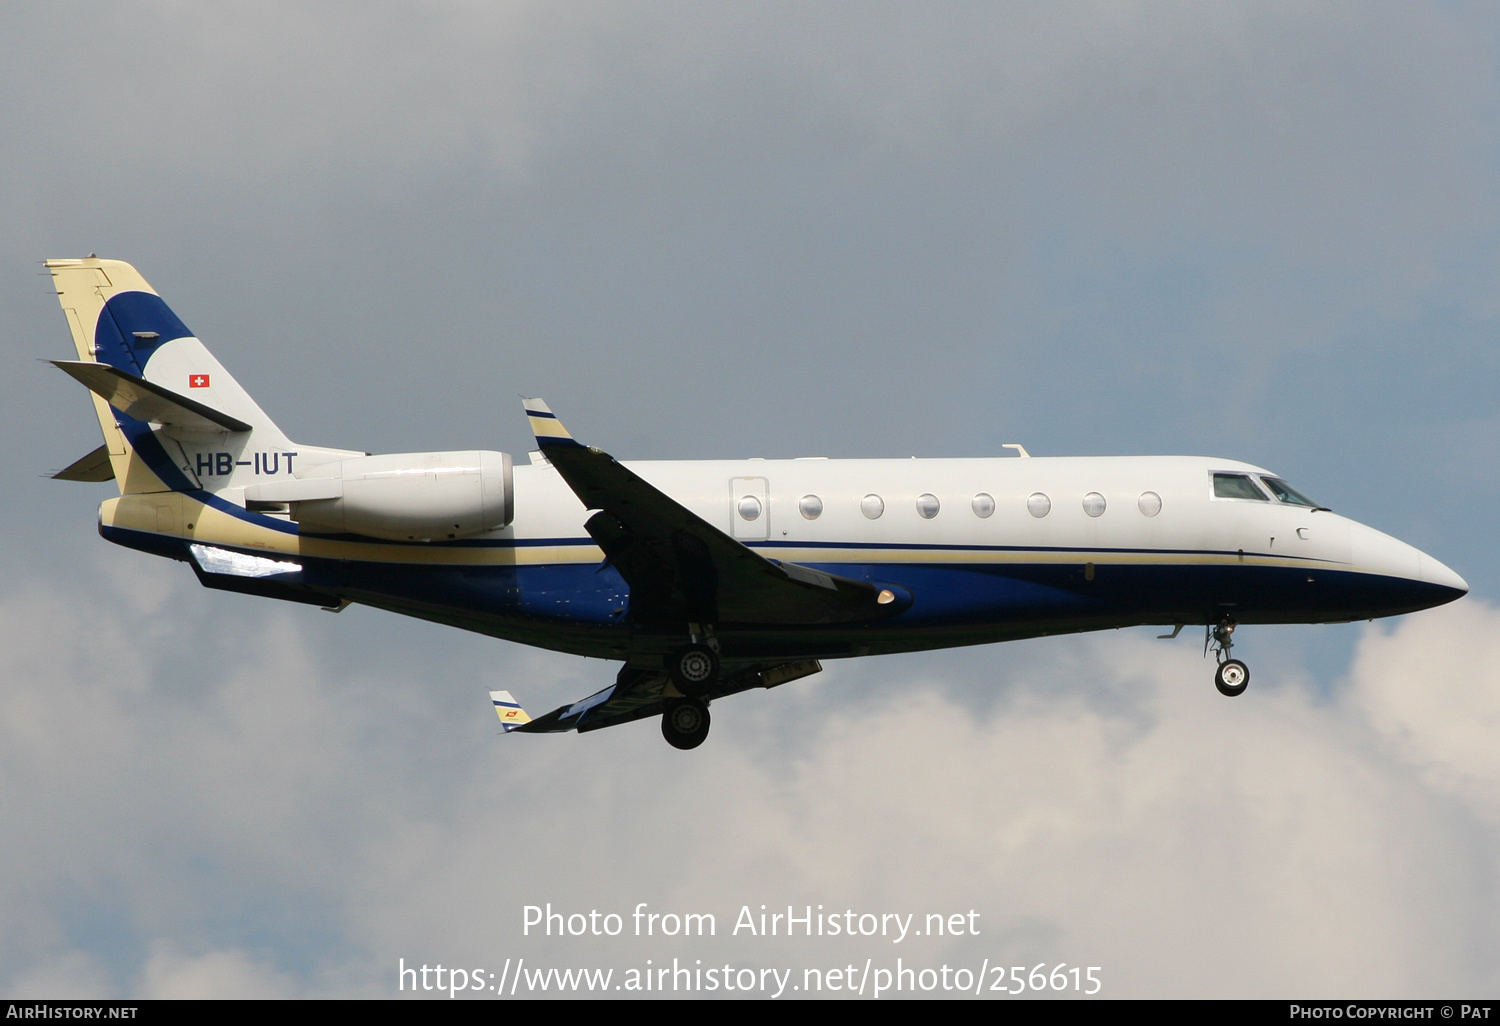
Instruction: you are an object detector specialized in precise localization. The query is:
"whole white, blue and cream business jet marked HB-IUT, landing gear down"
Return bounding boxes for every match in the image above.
[47,257,1469,749]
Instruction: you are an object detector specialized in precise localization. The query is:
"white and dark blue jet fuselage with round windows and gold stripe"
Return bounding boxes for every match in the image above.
[102,456,1464,660]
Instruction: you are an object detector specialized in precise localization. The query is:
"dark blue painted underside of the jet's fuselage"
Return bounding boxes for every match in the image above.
[101,525,1458,657]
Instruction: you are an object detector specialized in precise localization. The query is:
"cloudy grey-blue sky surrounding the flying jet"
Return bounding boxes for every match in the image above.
[0,2,1500,998]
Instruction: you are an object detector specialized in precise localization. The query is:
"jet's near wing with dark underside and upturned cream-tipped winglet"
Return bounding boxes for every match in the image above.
[527,399,911,626]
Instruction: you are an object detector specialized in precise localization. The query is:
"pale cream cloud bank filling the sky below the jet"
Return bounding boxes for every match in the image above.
[0,570,1500,996]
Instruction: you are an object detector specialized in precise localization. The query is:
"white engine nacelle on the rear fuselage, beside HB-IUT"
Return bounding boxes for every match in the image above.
[287,450,515,542]
